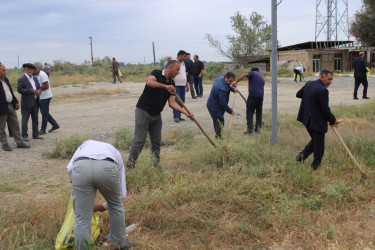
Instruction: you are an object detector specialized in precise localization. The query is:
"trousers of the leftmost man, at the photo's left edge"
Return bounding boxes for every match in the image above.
[0,104,23,145]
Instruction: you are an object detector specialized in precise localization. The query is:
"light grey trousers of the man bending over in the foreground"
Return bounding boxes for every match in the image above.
[72,160,129,250]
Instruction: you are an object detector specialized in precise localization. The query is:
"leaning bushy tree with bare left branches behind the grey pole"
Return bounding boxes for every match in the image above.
[205,12,271,65]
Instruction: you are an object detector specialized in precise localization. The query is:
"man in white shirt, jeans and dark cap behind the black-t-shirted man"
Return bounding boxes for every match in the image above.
[173,50,189,123]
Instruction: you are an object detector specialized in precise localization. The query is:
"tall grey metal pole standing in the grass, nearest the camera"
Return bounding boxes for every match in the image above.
[271,0,282,145]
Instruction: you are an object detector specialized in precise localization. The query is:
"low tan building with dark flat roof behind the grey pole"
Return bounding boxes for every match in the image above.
[277,41,375,72]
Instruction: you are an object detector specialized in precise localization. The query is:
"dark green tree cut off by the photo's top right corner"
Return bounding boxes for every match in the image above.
[350,0,375,46]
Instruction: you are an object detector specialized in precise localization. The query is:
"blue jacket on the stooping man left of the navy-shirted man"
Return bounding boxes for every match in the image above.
[207,76,234,118]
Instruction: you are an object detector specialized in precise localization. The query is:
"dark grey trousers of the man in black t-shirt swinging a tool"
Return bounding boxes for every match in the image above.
[129,108,163,166]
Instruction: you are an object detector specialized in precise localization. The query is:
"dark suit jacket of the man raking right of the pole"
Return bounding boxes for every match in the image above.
[296,80,336,133]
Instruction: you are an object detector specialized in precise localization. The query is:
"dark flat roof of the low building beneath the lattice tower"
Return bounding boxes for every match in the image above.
[277,41,354,51]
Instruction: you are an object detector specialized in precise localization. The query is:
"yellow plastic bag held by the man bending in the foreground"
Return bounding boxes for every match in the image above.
[55,196,100,249]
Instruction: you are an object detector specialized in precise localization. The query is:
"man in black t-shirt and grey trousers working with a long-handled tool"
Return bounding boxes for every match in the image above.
[126,60,194,170]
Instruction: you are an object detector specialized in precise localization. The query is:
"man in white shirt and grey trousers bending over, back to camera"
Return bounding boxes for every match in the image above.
[67,140,130,250]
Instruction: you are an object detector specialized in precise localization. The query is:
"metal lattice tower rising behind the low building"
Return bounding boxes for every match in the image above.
[315,0,350,41]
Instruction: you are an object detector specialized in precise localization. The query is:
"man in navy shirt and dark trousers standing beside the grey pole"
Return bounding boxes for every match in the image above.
[234,67,265,134]
